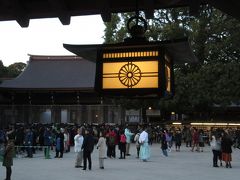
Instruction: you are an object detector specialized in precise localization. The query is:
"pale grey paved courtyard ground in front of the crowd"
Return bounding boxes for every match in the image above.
[0,144,240,180]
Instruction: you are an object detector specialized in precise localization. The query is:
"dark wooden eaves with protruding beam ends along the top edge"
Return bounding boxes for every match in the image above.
[0,0,240,27]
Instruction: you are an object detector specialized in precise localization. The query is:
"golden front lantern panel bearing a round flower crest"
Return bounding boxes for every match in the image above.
[102,60,159,89]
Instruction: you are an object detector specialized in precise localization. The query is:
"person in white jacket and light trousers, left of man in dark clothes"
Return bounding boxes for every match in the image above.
[74,128,83,168]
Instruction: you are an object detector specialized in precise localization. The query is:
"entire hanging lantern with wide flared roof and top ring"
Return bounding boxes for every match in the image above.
[64,15,196,97]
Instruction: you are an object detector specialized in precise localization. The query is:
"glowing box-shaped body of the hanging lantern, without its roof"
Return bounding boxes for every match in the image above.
[96,42,173,96]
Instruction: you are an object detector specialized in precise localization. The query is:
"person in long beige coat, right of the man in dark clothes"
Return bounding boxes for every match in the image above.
[97,132,106,169]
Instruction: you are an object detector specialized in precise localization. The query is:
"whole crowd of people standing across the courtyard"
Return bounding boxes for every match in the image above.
[0,124,240,180]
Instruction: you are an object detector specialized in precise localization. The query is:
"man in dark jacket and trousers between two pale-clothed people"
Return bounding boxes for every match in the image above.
[82,129,94,170]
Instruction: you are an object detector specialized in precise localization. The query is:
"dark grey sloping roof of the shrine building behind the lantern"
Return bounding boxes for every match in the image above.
[0,56,96,89]
